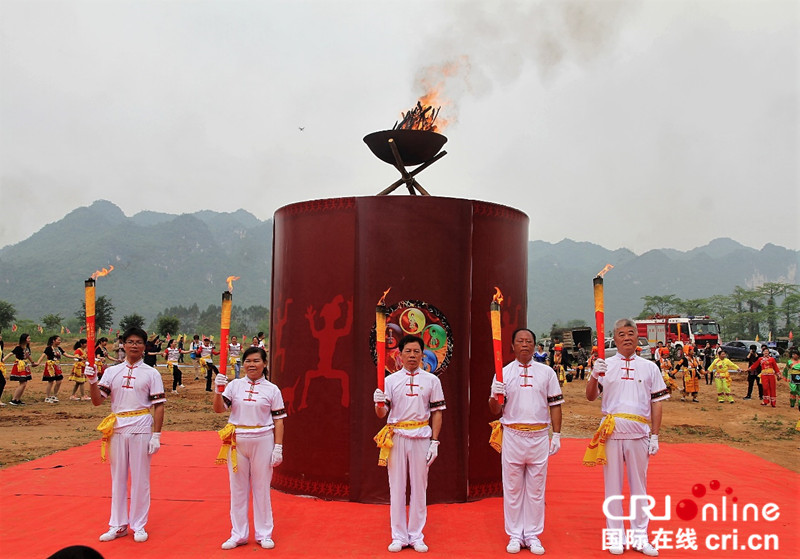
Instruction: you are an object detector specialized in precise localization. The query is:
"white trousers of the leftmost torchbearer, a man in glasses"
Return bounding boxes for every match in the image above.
[108,433,151,531]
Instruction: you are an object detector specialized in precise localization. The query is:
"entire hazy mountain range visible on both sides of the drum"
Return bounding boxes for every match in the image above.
[0,200,800,332]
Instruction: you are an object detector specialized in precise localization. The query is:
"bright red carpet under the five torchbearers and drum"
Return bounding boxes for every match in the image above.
[0,431,800,558]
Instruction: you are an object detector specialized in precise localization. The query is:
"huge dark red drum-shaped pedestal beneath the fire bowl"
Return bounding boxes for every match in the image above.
[270,196,528,503]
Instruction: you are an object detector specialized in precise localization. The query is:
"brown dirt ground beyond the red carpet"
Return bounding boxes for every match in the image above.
[0,354,800,472]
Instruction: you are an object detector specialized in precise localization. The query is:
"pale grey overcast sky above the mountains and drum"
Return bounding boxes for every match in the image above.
[0,0,800,253]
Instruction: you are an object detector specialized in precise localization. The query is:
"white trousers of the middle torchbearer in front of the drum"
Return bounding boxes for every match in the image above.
[386,431,431,545]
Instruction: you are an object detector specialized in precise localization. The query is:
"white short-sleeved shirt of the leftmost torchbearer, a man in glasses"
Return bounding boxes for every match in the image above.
[97,360,167,433]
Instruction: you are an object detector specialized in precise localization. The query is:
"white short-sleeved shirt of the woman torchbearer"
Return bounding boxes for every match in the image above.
[222,377,287,437]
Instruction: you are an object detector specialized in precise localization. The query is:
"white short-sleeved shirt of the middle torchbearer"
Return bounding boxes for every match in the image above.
[384,368,447,439]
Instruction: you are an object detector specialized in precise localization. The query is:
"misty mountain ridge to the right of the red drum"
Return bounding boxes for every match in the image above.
[528,239,800,332]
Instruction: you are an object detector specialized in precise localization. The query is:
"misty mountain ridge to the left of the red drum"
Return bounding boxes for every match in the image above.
[0,200,272,323]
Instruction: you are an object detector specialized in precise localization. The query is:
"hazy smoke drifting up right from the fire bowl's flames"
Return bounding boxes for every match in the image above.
[414,0,640,130]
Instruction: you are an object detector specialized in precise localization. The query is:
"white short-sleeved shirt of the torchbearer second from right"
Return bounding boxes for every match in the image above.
[500,360,564,425]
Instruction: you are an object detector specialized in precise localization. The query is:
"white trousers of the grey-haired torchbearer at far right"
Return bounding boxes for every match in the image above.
[603,437,650,541]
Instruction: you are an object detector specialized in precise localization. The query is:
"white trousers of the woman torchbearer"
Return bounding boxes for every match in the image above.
[228,430,275,543]
